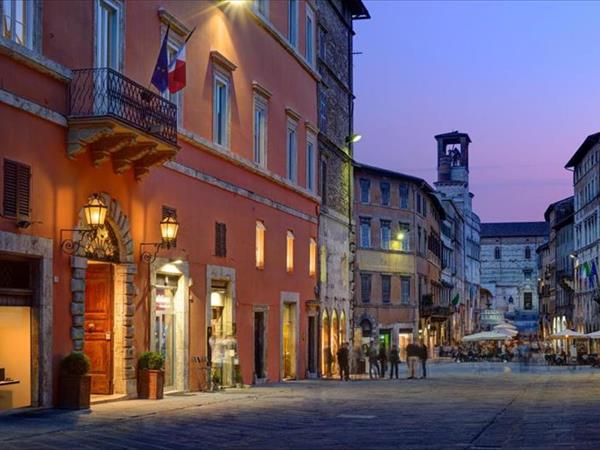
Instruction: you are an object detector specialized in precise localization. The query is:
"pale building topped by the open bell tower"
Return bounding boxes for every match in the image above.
[435,131,480,339]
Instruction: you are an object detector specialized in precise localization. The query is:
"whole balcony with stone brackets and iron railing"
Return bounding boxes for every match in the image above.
[67,68,179,180]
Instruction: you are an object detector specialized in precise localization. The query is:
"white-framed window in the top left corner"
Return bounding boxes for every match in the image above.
[0,0,36,49]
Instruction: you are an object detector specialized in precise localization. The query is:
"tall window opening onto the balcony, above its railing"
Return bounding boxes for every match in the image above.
[96,0,123,70]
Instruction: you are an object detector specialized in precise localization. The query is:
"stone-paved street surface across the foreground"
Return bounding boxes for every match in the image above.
[0,363,600,450]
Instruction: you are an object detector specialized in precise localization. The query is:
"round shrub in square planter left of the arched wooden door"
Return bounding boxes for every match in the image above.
[58,352,92,409]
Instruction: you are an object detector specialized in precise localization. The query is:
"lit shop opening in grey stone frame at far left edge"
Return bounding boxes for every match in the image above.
[0,236,52,411]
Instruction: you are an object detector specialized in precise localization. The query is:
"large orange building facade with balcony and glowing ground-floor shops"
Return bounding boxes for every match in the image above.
[0,0,320,409]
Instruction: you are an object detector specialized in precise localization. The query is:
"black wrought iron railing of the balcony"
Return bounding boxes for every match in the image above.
[69,68,177,144]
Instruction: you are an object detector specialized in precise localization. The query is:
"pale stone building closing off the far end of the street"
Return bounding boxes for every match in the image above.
[481,222,548,333]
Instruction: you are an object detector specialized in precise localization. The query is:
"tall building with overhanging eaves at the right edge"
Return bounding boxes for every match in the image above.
[565,133,600,332]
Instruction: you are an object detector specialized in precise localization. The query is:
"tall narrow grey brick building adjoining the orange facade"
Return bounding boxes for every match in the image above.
[317,0,369,375]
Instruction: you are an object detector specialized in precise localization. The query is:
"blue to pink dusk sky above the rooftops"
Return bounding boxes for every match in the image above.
[355,0,600,221]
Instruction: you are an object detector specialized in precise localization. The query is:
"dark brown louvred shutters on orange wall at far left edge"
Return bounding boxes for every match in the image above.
[3,159,31,218]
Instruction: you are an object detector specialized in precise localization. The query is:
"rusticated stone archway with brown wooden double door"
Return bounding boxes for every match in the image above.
[71,193,137,395]
